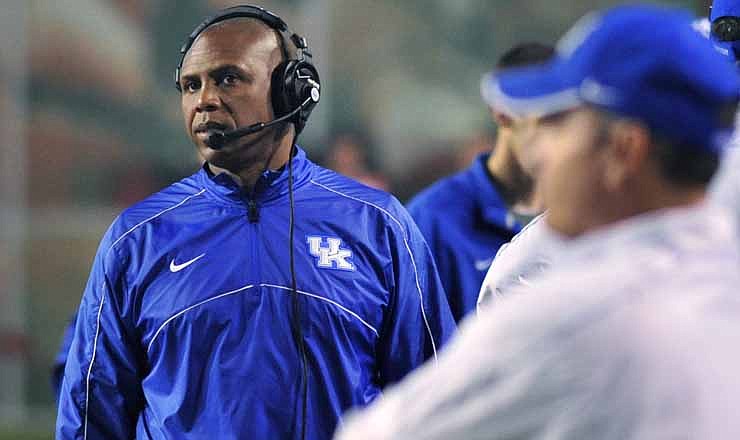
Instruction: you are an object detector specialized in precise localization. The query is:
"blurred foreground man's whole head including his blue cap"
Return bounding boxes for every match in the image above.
[492,6,740,236]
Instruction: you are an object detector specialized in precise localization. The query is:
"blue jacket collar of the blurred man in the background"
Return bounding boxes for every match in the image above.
[468,153,522,233]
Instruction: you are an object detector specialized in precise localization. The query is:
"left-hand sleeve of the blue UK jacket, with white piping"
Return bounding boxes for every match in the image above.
[56,239,144,439]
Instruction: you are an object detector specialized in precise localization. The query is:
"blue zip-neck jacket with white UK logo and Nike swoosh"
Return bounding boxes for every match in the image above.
[56,150,454,439]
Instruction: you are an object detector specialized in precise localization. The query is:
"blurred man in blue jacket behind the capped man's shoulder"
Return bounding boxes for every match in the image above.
[408,43,554,322]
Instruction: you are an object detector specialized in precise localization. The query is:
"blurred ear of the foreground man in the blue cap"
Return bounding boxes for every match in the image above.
[604,120,650,191]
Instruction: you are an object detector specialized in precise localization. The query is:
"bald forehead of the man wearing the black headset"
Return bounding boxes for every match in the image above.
[182,18,281,76]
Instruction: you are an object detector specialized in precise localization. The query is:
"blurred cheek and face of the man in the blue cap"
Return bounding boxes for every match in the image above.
[531,107,609,236]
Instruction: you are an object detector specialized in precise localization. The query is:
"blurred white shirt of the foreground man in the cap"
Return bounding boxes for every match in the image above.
[335,205,740,440]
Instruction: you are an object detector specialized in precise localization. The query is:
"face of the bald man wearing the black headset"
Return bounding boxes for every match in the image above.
[180,19,285,172]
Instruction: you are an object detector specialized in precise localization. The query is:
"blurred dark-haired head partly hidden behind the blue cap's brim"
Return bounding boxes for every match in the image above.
[481,43,555,177]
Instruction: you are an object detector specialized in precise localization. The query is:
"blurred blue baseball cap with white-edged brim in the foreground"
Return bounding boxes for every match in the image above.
[481,5,740,151]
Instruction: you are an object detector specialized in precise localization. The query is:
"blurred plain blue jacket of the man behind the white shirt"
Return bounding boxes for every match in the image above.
[407,154,522,322]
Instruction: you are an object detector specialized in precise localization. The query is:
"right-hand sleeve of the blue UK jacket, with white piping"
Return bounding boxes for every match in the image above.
[379,208,455,385]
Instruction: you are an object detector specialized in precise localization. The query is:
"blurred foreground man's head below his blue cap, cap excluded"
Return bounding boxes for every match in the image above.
[533,105,719,236]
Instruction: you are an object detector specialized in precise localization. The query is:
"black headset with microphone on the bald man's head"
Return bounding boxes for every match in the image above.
[175,5,321,144]
